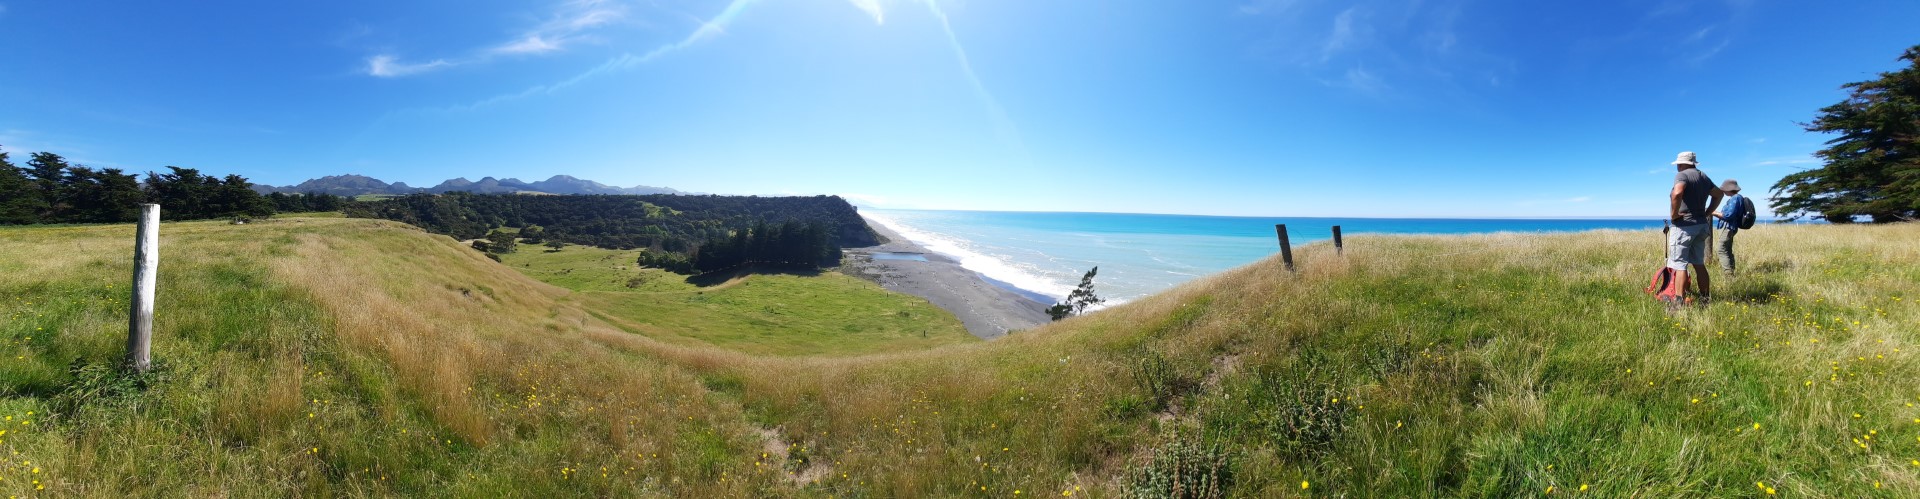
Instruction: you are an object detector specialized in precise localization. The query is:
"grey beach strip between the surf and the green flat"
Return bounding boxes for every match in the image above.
[845,214,1048,340]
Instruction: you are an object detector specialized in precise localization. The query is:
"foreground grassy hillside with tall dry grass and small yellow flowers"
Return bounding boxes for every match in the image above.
[0,219,1920,497]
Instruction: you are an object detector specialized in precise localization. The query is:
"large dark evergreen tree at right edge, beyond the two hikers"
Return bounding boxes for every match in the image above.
[1772,46,1920,223]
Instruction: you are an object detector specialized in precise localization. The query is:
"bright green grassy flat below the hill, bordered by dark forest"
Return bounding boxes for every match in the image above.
[501,244,979,355]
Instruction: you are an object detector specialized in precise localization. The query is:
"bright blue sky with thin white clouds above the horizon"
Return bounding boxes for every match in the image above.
[0,0,1920,217]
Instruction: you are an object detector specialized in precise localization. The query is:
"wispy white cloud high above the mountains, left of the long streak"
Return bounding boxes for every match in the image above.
[365,0,626,79]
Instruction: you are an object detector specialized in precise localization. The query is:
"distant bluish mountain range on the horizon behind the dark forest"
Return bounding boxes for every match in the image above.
[253,175,685,196]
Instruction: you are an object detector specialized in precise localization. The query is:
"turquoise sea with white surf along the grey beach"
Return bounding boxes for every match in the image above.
[860,207,1661,303]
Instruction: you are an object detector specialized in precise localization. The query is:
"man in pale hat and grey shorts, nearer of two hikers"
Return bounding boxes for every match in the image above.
[1667,152,1726,303]
